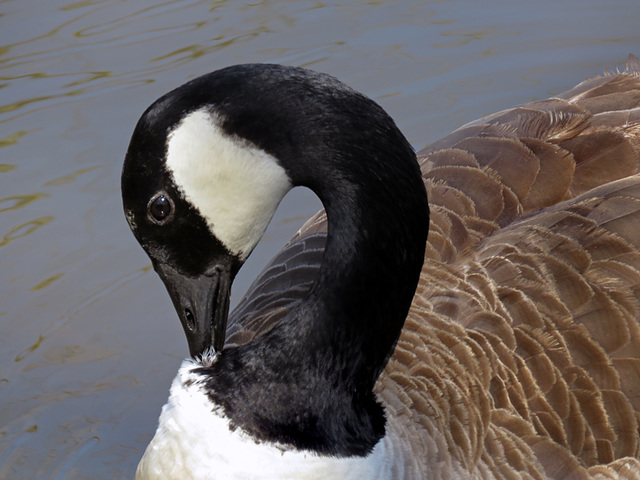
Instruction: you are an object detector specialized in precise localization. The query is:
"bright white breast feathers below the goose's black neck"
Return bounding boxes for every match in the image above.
[136,360,412,480]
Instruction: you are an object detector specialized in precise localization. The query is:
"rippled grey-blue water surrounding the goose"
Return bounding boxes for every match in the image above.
[0,0,640,480]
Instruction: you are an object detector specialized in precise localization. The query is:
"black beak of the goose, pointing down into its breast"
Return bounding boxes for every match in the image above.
[154,263,233,358]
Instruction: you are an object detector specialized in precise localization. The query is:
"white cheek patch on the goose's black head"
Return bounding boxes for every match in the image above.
[166,109,292,260]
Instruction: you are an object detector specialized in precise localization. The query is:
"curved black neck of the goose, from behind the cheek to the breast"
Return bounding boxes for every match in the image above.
[192,65,429,456]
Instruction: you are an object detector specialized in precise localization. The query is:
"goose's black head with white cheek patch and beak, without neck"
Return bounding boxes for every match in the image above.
[122,67,300,356]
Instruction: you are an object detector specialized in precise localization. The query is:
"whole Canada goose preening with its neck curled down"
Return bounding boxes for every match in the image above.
[122,56,640,480]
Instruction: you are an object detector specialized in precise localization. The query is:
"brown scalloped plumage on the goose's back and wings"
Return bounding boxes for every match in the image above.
[227,56,640,479]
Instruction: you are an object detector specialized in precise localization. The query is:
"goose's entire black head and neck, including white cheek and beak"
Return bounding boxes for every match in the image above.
[122,64,429,466]
